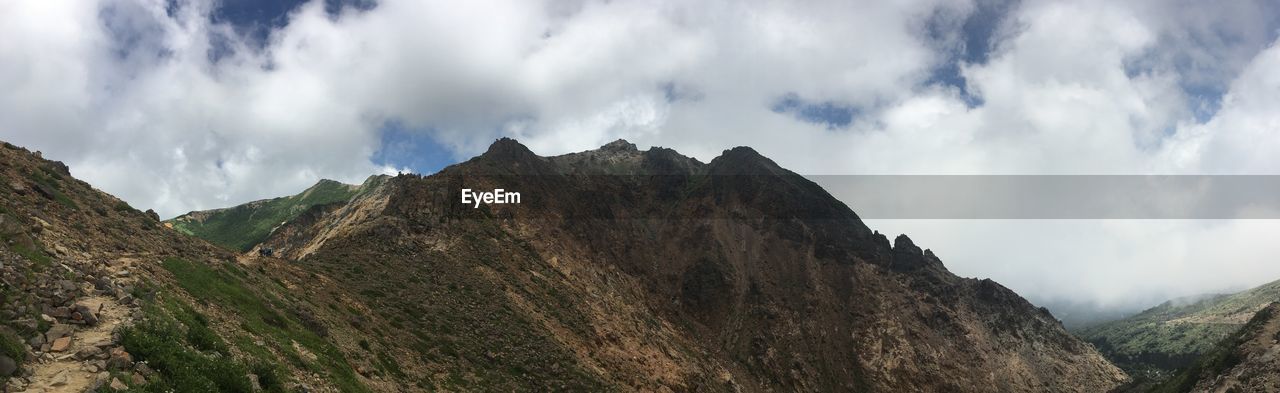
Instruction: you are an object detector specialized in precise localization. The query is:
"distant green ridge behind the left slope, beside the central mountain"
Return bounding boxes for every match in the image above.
[165,175,387,251]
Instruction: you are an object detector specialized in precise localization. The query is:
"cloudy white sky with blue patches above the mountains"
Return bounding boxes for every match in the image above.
[0,0,1280,316]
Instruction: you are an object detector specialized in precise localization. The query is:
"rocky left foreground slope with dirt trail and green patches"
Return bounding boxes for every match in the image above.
[0,143,381,392]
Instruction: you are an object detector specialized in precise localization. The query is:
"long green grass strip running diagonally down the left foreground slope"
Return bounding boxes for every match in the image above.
[161,257,367,392]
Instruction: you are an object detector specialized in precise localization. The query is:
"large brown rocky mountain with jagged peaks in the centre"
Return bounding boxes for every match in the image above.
[249,140,1125,392]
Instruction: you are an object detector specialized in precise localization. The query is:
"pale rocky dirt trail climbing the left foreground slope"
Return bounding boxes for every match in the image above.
[22,296,129,393]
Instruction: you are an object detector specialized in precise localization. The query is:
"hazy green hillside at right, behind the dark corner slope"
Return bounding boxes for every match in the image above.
[1076,280,1280,380]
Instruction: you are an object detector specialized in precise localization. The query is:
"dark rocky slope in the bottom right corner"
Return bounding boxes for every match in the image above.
[1152,302,1280,392]
